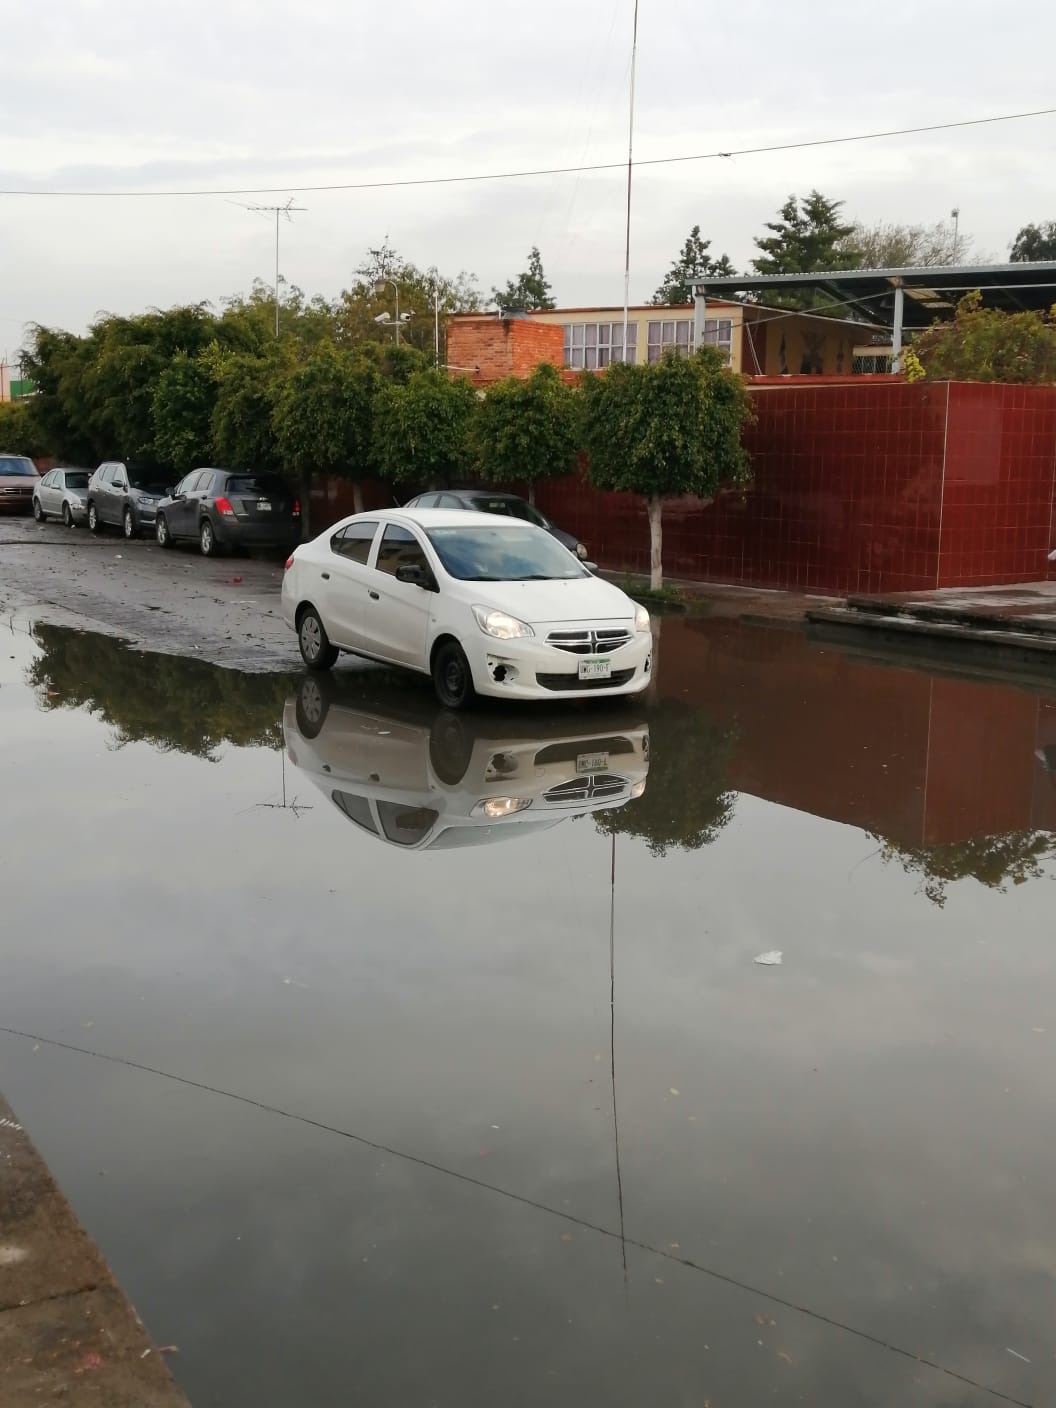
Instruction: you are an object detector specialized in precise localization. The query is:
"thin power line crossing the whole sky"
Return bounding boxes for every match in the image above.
[0,107,1056,200]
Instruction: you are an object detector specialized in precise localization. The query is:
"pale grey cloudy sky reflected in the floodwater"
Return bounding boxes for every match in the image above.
[0,632,1056,1408]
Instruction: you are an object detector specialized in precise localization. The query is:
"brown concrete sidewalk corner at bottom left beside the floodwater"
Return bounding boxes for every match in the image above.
[0,1097,189,1408]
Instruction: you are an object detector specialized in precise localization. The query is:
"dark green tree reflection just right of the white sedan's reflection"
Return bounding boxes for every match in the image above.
[594,698,736,856]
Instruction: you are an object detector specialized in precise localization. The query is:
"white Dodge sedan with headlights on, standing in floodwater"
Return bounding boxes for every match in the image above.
[282,508,652,708]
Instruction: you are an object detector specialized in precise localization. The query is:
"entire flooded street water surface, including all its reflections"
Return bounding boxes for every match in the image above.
[0,614,1056,1408]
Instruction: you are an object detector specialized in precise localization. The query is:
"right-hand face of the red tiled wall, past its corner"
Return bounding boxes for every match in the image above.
[939,382,1056,587]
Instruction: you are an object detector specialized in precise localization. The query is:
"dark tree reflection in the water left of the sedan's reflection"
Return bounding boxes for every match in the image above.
[27,622,296,760]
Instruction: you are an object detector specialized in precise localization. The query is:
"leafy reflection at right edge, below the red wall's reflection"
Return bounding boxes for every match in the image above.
[873,831,1056,908]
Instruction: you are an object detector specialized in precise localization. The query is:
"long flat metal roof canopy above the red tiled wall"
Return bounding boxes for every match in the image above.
[693,260,1056,329]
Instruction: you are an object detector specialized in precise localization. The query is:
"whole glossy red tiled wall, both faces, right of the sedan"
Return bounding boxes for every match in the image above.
[538,382,1056,593]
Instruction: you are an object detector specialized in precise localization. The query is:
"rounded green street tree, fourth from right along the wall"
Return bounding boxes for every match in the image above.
[273,342,380,513]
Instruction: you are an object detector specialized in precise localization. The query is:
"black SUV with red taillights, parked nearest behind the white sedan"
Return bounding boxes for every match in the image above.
[155,469,301,558]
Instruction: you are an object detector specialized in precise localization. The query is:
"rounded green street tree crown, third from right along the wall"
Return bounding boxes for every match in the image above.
[373,369,477,486]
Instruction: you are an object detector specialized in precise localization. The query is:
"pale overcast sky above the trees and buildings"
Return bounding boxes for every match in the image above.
[0,0,1056,355]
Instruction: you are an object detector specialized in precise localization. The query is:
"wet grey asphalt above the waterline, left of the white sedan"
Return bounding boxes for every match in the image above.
[0,517,300,672]
